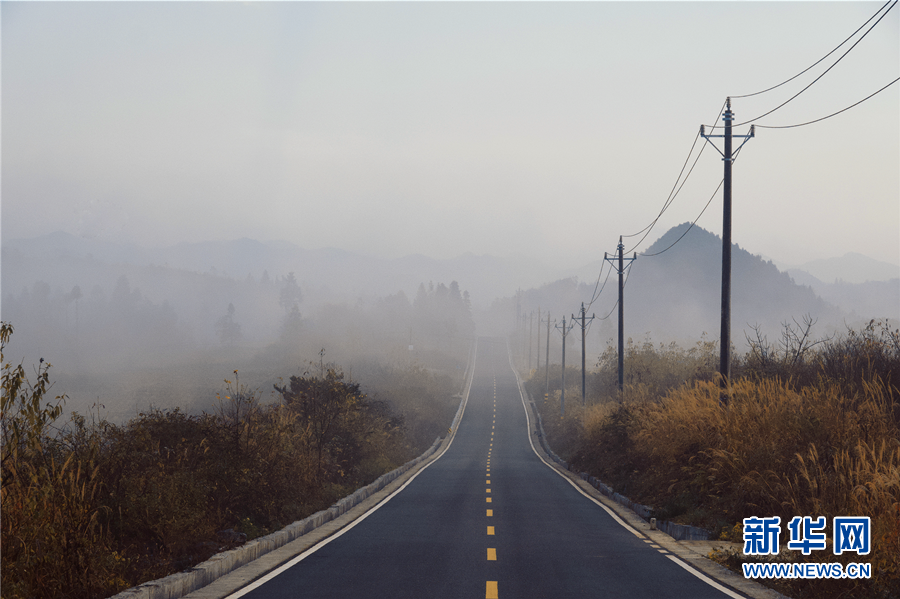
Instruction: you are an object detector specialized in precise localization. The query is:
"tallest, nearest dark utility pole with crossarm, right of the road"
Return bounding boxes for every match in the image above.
[700,98,755,400]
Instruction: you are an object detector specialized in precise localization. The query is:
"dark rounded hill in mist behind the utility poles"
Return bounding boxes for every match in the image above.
[625,223,844,344]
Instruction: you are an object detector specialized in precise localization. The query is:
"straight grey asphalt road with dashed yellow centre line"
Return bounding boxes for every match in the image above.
[232,339,741,599]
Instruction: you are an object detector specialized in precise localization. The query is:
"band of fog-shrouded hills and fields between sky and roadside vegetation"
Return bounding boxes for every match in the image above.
[2,224,900,420]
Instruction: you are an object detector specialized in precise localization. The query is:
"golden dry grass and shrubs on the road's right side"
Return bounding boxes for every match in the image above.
[526,320,900,599]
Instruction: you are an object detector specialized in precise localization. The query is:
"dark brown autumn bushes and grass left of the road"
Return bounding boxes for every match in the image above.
[0,323,462,599]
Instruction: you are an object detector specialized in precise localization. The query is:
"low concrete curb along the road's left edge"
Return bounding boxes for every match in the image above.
[110,346,475,599]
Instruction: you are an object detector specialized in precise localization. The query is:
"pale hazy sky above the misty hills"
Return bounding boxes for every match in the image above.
[0,1,900,266]
